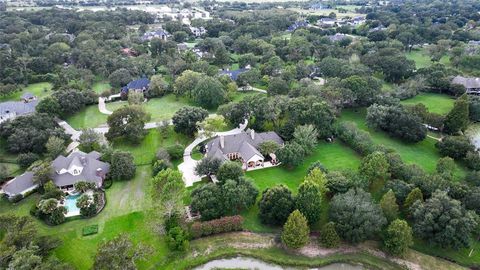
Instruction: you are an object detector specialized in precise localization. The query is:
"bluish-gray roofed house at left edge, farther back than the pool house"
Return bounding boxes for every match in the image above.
[0,93,38,123]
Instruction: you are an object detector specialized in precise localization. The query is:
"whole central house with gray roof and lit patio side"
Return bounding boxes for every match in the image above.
[205,129,284,170]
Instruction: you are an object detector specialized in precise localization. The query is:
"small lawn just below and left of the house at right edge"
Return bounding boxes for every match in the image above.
[402,93,455,115]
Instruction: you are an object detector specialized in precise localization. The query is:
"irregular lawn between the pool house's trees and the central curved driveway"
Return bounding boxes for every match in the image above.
[113,127,193,165]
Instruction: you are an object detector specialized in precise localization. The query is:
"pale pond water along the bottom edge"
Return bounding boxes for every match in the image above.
[194,257,364,270]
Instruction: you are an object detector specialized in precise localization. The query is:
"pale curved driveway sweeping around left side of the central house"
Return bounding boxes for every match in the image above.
[178,120,248,187]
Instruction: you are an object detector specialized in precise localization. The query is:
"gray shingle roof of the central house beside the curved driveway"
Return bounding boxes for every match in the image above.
[207,130,283,161]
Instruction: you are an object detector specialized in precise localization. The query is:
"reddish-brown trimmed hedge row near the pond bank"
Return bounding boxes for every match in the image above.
[191,215,243,238]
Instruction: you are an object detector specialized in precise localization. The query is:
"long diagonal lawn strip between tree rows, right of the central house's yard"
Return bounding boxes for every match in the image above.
[340,108,466,176]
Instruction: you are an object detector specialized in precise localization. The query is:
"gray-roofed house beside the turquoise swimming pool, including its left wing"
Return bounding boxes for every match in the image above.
[3,151,110,198]
